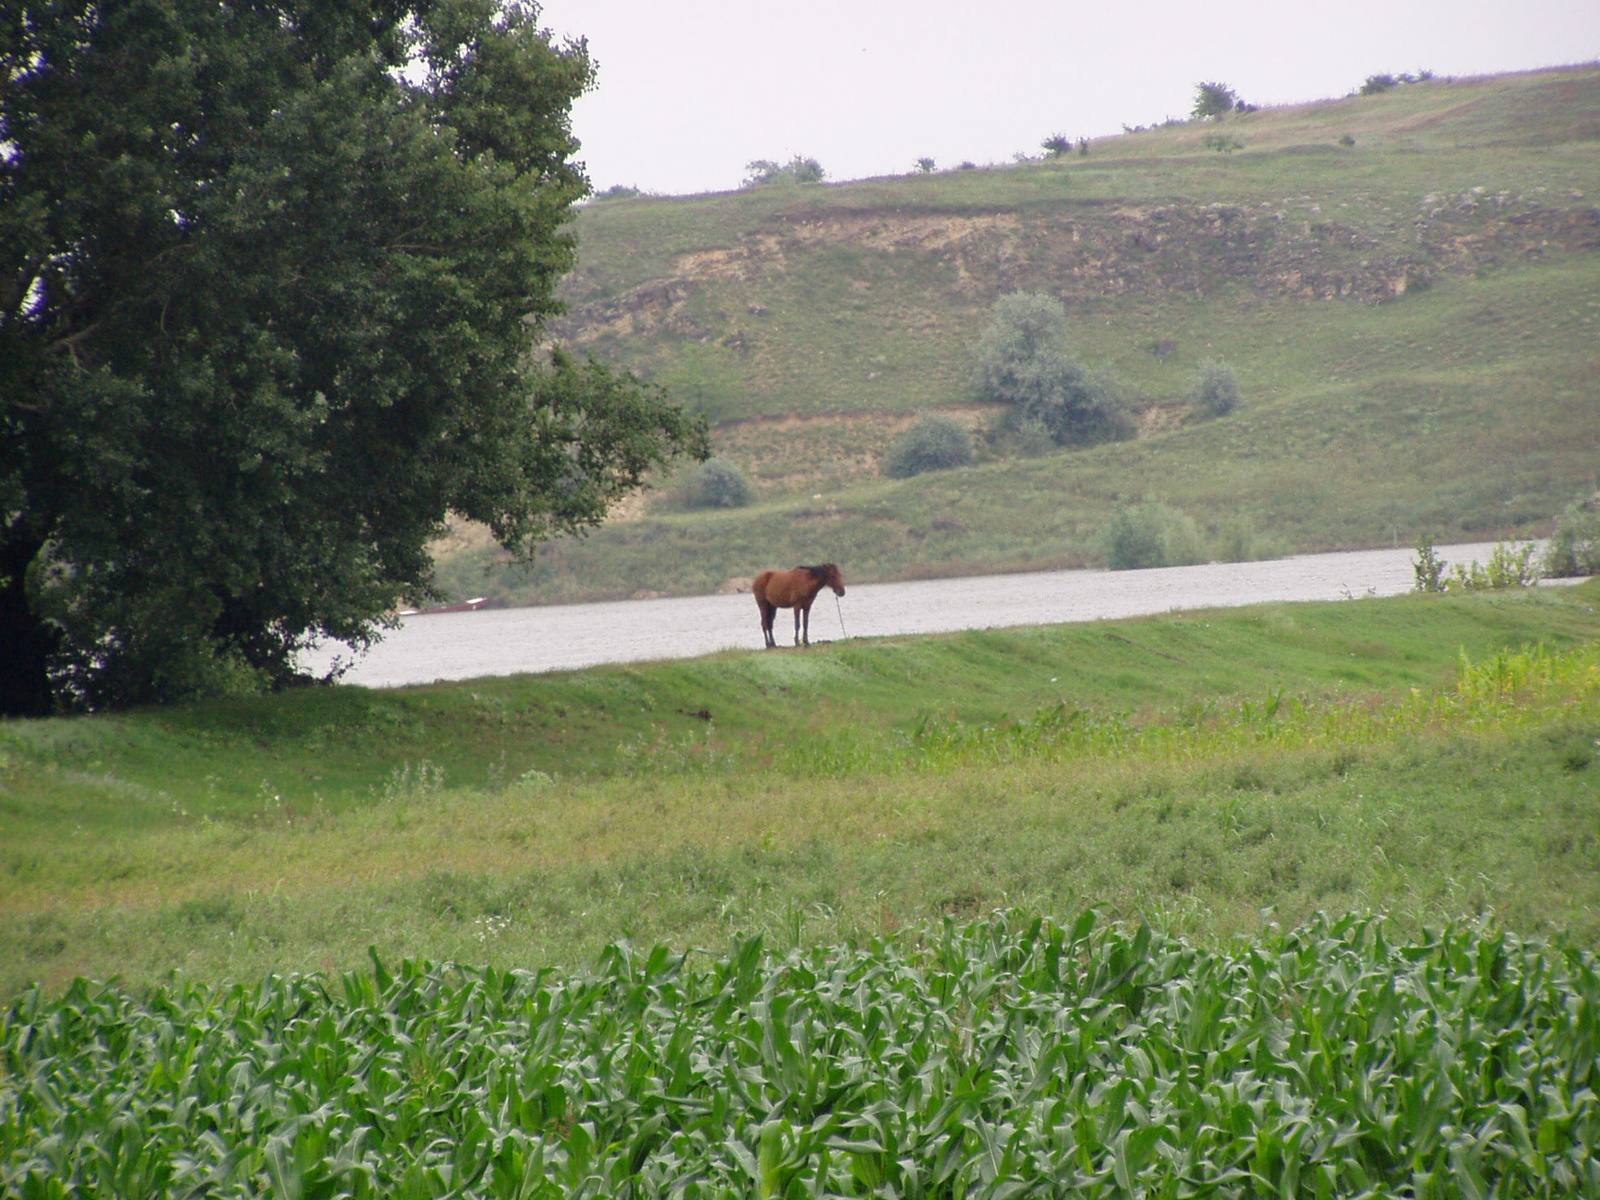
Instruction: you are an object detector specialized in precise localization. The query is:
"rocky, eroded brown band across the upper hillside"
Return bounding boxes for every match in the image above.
[554,197,1600,344]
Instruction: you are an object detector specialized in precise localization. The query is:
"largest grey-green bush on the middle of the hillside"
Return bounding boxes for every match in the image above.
[978,291,1133,445]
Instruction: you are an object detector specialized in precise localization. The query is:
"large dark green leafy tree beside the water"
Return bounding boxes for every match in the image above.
[0,0,706,714]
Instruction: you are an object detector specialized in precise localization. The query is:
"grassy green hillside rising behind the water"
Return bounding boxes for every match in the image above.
[440,66,1600,603]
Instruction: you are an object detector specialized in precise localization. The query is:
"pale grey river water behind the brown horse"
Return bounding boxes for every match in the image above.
[304,542,1561,688]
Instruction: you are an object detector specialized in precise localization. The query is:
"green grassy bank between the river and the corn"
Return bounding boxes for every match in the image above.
[0,582,1600,992]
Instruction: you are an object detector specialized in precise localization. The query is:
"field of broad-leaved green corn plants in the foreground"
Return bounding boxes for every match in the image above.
[0,912,1600,1200]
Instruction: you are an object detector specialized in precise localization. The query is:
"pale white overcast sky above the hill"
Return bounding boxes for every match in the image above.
[541,0,1600,195]
